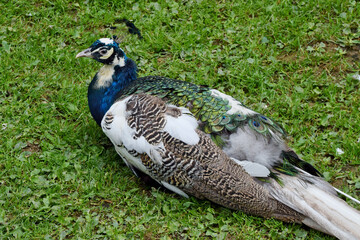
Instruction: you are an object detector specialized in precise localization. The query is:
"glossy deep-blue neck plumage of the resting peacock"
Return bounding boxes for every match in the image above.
[88,58,137,126]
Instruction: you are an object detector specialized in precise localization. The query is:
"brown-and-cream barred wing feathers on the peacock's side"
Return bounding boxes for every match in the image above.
[117,94,304,222]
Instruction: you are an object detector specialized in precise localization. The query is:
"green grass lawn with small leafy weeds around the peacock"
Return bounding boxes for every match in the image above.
[0,0,360,239]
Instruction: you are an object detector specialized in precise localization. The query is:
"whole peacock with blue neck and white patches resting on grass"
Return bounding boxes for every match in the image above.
[76,38,360,239]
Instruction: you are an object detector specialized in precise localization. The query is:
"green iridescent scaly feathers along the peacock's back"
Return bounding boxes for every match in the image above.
[118,76,284,142]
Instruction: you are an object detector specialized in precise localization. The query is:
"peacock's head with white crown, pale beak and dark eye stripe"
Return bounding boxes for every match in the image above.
[76,37,127,67]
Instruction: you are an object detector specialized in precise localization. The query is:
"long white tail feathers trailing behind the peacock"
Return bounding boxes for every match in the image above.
[265,172,360,239]
